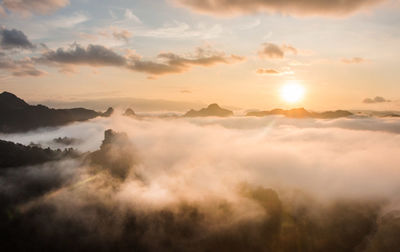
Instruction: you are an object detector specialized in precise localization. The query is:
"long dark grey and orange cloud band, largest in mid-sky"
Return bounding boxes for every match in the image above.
[34,44,244,76]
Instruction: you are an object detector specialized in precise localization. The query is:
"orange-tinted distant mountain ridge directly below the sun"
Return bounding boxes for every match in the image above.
[246,108,353,119]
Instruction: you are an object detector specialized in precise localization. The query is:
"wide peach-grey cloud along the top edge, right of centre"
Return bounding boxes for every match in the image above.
[175,0,385,16]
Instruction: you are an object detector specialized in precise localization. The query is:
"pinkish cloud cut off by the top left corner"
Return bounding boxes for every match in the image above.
[2,0,69,16]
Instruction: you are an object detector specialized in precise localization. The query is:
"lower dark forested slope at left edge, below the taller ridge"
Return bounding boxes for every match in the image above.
[0,140,79,168]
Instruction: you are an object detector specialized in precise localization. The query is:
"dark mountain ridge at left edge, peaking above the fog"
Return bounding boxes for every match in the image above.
[0,92,107,133]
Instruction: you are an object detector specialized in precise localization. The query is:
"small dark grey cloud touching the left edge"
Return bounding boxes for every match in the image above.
[0,28,35,49]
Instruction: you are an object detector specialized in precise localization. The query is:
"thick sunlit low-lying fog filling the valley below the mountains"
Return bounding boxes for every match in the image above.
[0,113,400,251]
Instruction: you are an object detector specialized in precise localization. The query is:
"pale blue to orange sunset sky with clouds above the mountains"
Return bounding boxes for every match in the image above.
[0,0,400,110]
